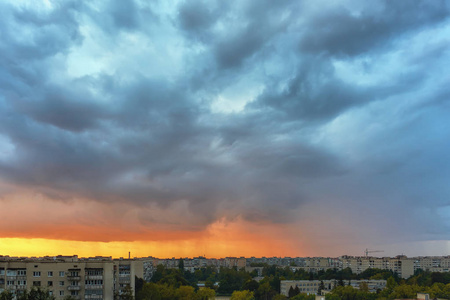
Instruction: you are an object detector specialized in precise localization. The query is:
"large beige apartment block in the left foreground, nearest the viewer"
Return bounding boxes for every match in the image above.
[0,256,143,300]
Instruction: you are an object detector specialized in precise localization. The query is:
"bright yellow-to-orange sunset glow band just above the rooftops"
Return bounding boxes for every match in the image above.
[0,221,299,258]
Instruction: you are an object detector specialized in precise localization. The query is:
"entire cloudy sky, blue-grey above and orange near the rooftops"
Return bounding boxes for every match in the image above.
[0,0,450,257]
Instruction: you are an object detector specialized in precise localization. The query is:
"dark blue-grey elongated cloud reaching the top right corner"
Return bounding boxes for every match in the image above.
[299,1,449,56]
